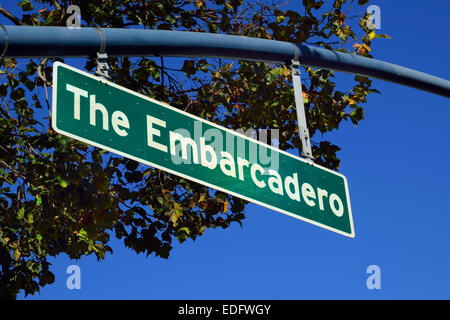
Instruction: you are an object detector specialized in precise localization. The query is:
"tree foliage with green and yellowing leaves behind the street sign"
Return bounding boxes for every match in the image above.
[0,0,383,298]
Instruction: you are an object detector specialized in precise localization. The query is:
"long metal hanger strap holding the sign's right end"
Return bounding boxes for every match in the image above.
[291,59,314,161]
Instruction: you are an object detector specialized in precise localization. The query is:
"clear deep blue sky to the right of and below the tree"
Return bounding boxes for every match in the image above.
[0,0,450,299]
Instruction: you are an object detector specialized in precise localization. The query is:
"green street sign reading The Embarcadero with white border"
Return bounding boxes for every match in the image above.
[52,62,355,238]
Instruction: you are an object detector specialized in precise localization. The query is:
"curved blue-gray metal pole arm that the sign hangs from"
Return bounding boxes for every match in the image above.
[0,26,450,98]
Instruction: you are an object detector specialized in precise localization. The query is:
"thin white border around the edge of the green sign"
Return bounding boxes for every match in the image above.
[52,61,355,238]
